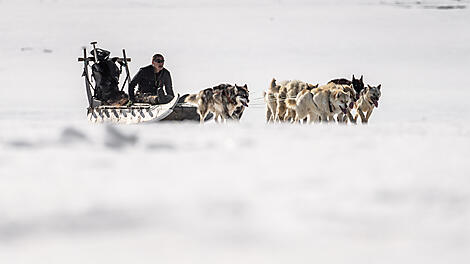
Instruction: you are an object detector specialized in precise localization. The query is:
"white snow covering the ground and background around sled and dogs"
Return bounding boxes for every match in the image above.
[0,0,470,263]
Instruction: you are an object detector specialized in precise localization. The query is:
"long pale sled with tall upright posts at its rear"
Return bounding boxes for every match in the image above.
[78,42,213,124]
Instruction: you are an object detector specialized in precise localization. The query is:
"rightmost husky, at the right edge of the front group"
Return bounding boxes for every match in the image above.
[354,84,382,124]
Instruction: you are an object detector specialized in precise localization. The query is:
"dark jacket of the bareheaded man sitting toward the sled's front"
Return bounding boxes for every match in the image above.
[129,65,175,99]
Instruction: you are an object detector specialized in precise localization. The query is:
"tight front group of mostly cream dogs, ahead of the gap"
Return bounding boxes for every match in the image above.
[264,75,381,123]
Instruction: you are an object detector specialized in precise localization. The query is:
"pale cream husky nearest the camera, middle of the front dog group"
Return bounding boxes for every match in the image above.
[292,84,352,123]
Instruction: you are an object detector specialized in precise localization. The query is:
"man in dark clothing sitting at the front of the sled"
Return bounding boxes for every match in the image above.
[129,54,175,104]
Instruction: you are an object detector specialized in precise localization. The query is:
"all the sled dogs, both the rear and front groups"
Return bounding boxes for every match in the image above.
[184,75,381,124]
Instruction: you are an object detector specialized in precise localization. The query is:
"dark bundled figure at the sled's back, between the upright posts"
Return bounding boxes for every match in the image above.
[91,48,127,105]
